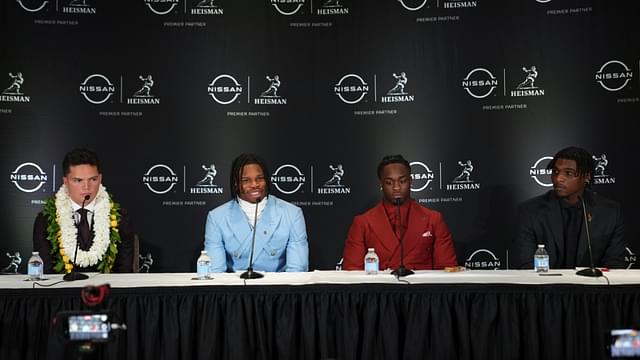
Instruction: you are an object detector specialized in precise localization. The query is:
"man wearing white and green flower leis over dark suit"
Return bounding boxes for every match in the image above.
[33,149,133,273]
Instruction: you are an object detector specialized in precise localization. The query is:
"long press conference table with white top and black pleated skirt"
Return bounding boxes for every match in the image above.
[0,270,640,359]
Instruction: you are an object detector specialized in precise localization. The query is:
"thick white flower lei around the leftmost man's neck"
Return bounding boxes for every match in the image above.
[56,184,111,267]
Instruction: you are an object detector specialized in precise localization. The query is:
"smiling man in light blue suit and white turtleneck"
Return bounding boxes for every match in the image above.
[204,154,309,272]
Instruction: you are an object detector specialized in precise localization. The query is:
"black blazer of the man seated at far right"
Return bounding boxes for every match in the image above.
[512,190,625,269]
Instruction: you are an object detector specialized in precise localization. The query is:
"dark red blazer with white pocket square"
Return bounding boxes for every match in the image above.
[342,200,458,270]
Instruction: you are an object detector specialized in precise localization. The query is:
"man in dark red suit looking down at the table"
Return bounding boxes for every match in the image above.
[343,155,458,270]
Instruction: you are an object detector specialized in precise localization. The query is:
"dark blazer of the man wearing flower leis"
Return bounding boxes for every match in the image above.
[33,209,134,273]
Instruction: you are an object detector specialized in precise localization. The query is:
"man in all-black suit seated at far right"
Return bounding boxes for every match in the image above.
[513,147,625,269]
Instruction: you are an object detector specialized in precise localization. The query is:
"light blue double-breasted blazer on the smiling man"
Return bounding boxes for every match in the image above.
[204,195,309,272]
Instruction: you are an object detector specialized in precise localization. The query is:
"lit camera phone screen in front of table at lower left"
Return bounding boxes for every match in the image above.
[63,313,111,342]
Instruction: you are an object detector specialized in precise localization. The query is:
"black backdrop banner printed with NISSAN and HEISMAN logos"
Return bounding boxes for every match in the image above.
[0,0,640,272]
